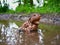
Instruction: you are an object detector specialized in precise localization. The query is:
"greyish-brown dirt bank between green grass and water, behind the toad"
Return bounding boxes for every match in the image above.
[0,13,60,25]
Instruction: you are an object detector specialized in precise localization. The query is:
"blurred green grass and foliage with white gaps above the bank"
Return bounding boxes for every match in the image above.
[0,0,60,13]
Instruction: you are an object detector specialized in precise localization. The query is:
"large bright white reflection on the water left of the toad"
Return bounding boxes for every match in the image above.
[0,23,18,45]
